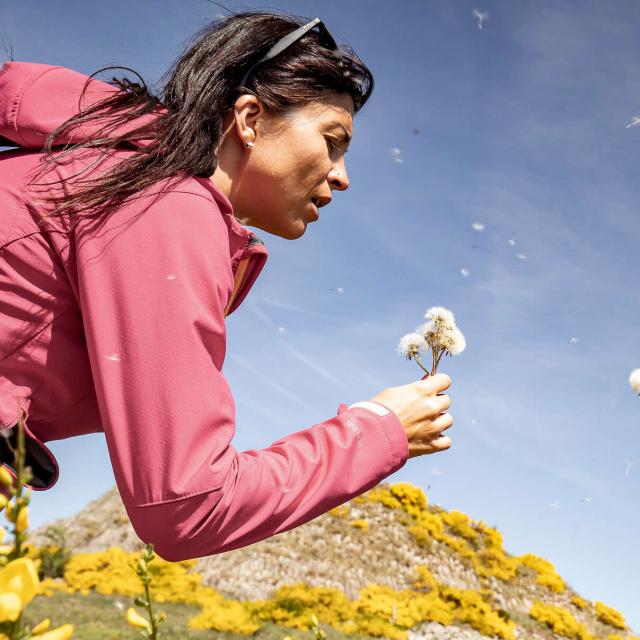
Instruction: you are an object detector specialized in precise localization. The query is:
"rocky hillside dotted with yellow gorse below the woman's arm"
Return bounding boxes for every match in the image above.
[30,483,633,640]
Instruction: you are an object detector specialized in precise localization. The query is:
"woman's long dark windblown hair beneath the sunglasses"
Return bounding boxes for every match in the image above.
[30,11,373,225]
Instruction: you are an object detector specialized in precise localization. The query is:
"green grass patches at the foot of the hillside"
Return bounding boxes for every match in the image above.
[23,591,380,640]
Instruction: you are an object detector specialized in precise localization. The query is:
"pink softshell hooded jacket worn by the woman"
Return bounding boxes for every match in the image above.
[0,62,408,561]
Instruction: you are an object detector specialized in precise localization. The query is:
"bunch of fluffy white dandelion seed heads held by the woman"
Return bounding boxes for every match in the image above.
[396,307,467,376]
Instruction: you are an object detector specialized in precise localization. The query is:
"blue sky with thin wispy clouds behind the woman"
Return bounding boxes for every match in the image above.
[0,0,640,630]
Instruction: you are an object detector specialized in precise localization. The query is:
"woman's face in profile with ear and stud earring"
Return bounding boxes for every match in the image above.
[211,94,353,240]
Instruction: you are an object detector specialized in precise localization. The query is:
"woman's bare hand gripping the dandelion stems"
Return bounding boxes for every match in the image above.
[370,373,453,458]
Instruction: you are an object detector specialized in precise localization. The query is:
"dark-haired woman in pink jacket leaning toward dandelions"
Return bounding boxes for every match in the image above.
[0,12,452,561]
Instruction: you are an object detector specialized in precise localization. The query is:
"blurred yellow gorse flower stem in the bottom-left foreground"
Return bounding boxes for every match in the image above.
[0,411,74,640]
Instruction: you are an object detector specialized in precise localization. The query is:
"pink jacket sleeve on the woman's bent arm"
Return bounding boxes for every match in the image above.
[74,184,408,561]
